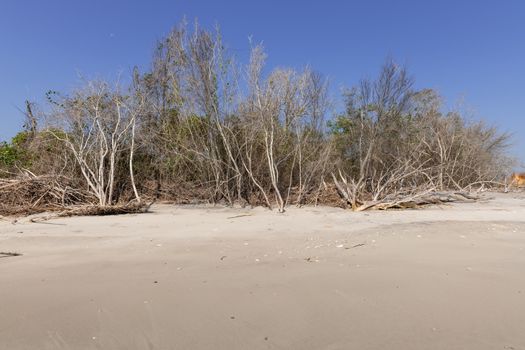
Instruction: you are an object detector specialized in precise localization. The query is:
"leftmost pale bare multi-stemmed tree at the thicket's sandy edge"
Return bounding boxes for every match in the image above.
[48,82,141,206]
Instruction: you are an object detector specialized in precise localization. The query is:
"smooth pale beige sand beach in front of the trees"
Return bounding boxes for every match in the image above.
[0,194,525,350]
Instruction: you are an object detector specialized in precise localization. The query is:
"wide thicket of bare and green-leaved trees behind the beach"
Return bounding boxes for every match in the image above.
[0,21,510,211]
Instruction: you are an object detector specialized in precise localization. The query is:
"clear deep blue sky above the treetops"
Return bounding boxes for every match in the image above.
[0,0,525,160]
